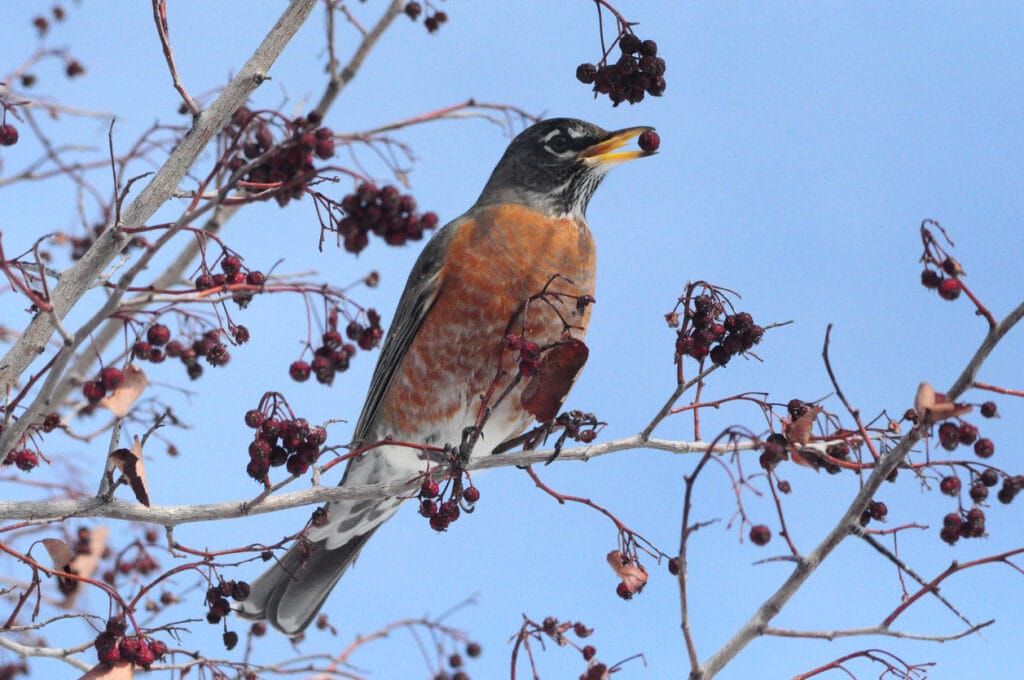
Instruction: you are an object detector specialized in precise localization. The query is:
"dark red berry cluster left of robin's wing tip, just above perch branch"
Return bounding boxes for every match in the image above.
[246,398,327,486]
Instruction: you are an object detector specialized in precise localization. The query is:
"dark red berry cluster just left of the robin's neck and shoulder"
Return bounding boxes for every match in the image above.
[338,182,437,253]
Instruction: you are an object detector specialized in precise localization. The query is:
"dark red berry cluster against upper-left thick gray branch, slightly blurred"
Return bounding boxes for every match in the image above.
[227,107,335,207]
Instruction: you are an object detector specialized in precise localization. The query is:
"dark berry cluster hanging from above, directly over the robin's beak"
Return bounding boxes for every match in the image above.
[577,29,665,107]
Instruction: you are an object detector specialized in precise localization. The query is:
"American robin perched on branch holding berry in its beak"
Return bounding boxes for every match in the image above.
[240,118,651,635]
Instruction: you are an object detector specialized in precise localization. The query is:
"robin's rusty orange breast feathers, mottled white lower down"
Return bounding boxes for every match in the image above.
[381,205,596,436]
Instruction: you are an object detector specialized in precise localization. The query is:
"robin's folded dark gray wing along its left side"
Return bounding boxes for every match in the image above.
[350,215,467,450]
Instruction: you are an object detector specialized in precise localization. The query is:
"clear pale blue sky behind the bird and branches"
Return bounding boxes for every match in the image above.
[0,0,1024,679]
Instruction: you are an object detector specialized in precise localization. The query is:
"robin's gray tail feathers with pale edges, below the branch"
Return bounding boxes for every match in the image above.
[238,523,380,636]
